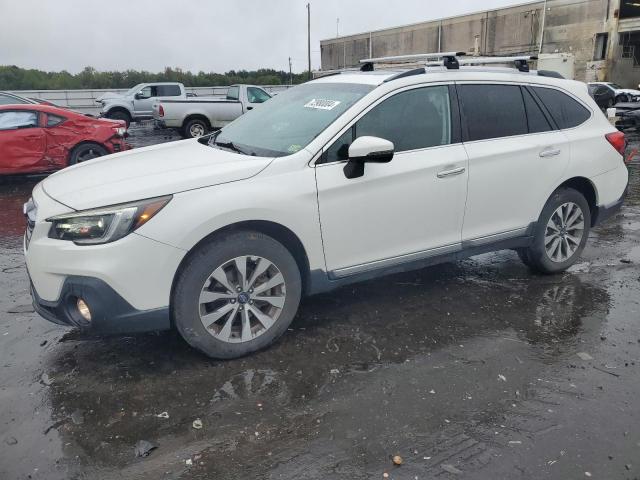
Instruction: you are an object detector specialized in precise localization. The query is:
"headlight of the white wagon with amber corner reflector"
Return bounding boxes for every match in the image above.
[47,195,172,245]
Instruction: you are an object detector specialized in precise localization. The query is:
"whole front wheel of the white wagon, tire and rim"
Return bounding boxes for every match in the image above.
[171,231,302,359]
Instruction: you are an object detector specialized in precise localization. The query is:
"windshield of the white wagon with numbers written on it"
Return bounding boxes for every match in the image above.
[209,83,374,157]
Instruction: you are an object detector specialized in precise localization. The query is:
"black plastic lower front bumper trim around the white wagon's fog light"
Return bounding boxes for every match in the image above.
[31,276,171,333]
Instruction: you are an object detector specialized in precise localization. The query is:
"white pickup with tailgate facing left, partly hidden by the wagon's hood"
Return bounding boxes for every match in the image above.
[153,85,271,138]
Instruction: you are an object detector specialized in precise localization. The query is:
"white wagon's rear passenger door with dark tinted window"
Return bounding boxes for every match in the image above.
[457,82,570,246]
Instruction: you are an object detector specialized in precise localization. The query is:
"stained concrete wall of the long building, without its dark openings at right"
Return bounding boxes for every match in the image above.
[320,0,620,83]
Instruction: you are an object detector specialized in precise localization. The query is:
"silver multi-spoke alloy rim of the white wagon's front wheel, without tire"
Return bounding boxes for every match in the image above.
[199,255,286,343]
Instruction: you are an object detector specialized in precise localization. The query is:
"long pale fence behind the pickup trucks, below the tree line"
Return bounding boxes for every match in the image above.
[12,85,289,115]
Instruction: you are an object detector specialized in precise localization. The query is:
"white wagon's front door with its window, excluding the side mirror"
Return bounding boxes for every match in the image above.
[316,85,467,278]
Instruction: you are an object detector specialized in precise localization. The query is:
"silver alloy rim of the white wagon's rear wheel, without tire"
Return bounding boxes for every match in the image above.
[544,202,584,263]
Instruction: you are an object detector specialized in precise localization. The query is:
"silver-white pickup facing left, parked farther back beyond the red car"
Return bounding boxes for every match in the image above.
[96,82,189,126]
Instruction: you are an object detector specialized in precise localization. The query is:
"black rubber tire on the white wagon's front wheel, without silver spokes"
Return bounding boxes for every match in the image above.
[171,231,302,359]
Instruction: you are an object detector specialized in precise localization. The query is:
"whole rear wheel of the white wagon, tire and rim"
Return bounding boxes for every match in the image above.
[518,188,591,273]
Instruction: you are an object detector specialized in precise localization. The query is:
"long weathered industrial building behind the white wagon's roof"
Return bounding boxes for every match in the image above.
[320,0,640,88]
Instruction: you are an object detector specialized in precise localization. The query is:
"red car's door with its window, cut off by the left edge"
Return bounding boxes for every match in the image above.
[0,110,47,174]
